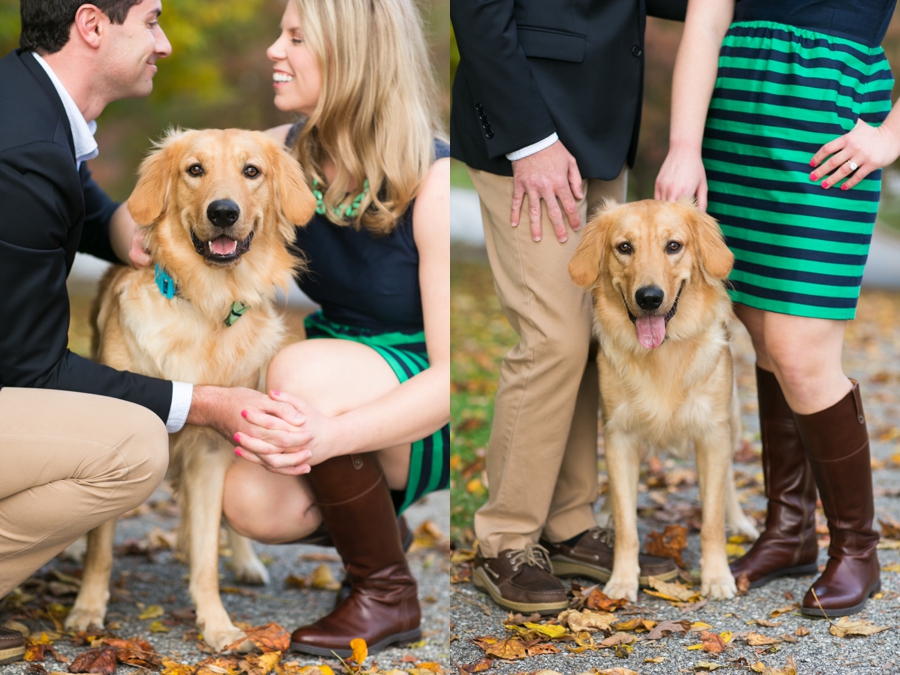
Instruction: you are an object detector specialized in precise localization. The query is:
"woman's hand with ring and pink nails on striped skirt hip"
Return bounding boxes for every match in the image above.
[809,119,900,190]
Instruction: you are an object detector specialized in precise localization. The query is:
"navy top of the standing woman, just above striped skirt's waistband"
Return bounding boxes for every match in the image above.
[734,0,896,47]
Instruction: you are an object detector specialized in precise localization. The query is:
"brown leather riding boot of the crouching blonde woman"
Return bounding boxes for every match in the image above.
[291,452,422,658]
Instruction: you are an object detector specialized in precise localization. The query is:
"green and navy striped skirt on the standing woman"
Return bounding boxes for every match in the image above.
[703,21,894,319]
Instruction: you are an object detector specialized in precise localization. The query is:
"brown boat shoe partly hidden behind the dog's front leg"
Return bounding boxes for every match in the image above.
[541,527,678,586]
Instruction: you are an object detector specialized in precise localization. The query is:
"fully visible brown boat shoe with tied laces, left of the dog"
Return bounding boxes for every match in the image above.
[472,544,569,614]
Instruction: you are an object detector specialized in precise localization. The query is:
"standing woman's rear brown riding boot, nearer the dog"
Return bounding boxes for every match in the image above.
[730,366,819,588]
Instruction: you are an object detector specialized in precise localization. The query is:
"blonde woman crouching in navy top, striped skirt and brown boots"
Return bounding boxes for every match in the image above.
[224,0,450,656]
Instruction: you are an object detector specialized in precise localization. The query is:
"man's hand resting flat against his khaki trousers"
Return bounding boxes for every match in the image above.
[510,141,584,242]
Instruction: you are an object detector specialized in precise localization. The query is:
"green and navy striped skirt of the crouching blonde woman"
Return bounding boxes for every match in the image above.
[304,310,450,514]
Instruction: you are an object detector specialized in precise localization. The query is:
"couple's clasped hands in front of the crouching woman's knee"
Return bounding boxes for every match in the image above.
[187,386,321,476]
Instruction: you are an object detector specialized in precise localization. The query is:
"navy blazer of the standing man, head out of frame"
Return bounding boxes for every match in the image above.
[450,0,687,180]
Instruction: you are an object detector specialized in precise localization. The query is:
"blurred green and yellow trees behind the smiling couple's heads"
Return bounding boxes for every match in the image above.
[0,0,450,200]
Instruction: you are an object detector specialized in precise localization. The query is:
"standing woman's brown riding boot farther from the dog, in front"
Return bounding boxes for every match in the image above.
[795,381,881,617]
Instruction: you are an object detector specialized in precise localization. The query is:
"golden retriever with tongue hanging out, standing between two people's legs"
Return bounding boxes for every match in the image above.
[569,200,759,600]
